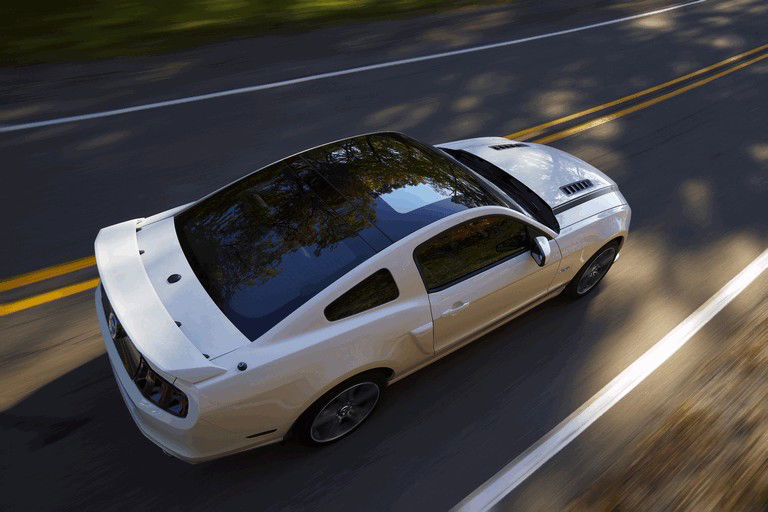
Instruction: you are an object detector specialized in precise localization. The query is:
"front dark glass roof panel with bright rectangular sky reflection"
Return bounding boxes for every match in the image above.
[301,134,504,241]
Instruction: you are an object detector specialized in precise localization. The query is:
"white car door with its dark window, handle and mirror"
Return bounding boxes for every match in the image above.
[414,215,560,352]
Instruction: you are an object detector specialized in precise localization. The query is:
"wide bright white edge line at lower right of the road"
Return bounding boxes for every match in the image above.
[452,249,768,512]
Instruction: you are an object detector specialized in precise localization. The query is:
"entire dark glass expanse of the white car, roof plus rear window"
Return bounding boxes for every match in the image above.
[175,134,503,340]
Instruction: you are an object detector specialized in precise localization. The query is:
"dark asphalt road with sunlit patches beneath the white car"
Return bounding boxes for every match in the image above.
[0,0,768,510]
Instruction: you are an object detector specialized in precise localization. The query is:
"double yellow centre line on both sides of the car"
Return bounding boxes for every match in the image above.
[0,44,768,316]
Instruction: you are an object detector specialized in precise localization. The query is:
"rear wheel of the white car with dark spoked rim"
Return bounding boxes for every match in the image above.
[294,372,386,446]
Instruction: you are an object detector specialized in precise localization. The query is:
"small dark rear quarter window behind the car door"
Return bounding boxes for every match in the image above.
[325,269,400,321]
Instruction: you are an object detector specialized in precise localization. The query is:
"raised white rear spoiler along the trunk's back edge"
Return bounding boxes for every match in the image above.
[94,219,226,383]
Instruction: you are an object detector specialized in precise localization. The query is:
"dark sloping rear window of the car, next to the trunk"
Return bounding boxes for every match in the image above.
[175,157,374,340]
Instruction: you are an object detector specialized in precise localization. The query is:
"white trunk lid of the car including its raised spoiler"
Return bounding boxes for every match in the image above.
[95,217,249,382]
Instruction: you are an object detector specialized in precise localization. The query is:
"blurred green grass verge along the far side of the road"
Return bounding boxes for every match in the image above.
[0,0,510,66]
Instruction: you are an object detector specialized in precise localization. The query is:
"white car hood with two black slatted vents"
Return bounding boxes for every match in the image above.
[438,137,616,208]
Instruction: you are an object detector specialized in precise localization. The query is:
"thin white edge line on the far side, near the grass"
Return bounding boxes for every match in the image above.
[0,0,707,133]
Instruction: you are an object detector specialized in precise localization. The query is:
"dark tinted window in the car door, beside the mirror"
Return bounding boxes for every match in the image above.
[413,215,530,292]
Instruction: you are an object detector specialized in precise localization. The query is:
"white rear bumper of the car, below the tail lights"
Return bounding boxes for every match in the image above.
[96,287,274,464]
